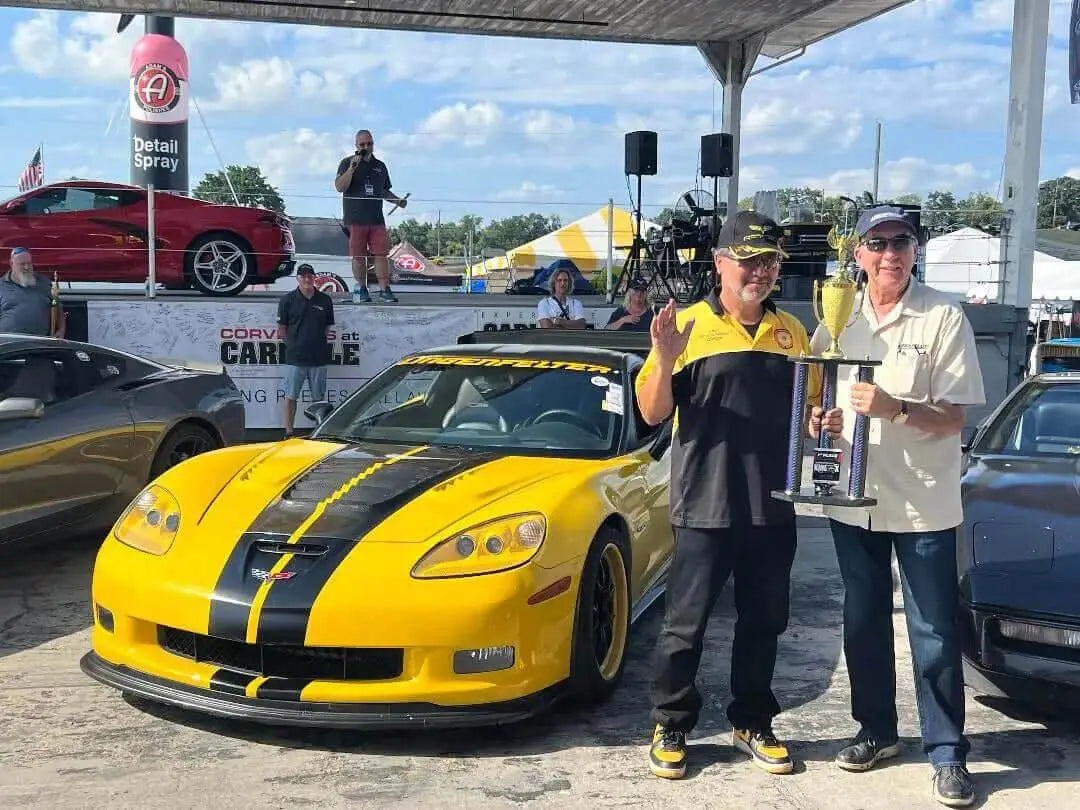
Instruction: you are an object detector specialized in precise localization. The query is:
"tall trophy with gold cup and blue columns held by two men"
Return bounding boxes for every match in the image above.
[772,226,881,507]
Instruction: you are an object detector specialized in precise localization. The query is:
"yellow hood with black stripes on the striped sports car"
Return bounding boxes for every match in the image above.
[201,440,582,543]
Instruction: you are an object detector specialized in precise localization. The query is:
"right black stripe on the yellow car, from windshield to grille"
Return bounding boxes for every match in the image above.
[256,447,502,645]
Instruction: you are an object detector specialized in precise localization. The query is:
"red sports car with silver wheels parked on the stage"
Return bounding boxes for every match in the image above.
[0,180,296,295]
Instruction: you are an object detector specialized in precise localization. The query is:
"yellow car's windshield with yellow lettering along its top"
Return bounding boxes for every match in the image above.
[312,355,625,458]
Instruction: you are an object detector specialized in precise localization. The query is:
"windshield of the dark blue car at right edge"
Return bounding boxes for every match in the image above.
[974,382,1080,456]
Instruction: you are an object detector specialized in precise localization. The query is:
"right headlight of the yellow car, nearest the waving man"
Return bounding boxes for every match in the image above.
[413,514,548,579]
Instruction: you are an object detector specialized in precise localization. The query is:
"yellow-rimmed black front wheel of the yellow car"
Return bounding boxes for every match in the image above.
[570,526,631,704]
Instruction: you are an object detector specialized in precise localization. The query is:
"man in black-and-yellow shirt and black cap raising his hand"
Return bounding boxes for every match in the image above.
[635,211,839,779]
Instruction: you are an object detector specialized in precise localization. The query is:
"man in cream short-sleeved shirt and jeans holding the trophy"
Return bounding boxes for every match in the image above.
[809,206,985,807]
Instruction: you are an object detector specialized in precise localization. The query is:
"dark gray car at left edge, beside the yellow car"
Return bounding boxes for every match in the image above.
[0,334,244,544]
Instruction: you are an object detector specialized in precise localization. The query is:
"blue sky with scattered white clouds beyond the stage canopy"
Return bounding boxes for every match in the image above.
[0,0,1080,224]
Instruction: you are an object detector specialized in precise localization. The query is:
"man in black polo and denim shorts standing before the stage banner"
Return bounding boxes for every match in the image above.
[278,265,334,438]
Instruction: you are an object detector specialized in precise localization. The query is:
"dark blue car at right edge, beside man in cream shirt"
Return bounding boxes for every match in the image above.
[958,373,1080,703]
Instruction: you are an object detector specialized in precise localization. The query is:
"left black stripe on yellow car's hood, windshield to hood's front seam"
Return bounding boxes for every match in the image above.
[248,444,416,536]
